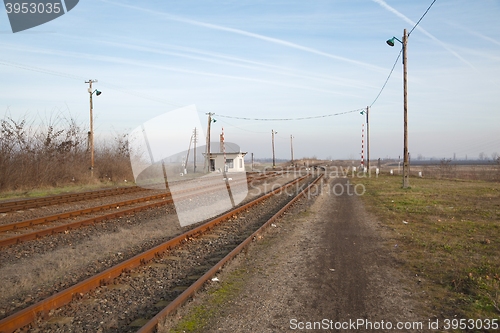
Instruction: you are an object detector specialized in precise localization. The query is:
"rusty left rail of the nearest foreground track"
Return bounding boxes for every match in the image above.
[0,175,307,333]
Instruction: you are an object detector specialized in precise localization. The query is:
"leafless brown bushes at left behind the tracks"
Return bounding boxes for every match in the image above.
[0,116,131,191]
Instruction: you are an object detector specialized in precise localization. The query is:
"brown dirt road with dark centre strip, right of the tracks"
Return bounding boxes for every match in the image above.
[170,178,428,332]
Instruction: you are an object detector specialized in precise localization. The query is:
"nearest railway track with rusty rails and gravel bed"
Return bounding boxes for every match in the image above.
[0,172,319,332]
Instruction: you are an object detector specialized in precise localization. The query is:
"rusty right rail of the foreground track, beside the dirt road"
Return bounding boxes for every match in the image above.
[137,174,323,333]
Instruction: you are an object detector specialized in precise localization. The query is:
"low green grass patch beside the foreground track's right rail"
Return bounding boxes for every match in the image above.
[170,269,247,333]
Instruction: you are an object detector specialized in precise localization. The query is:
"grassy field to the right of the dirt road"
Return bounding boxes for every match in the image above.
[353,176,500,319]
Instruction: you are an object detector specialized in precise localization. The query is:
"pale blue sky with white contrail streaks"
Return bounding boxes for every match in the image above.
[0,0,500,160]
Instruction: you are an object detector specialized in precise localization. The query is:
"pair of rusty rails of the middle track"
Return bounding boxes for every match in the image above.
[0,171,273,248]
